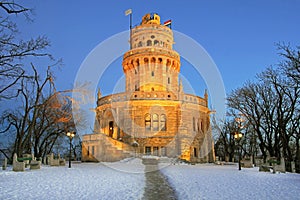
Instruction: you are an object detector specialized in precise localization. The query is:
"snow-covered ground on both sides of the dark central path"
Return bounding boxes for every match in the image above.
[0,159,300,200]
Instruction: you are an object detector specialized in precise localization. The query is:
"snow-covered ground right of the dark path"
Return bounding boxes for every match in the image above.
[161,164,300,199]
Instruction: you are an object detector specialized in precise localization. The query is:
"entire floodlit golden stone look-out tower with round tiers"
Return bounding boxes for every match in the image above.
[82,14,214,162]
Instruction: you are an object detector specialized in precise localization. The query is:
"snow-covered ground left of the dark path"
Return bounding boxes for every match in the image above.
[0,159,145,200]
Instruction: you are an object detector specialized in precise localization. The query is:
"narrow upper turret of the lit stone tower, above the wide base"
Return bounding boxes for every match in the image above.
[122,14,180,93]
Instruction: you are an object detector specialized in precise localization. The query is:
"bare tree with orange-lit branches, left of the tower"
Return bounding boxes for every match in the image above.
[1,65,86,161]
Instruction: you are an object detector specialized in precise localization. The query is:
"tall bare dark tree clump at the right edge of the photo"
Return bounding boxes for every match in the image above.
[228,43,300,170]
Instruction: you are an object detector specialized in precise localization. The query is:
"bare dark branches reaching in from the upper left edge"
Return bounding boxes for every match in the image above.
[0,1,52,100]
